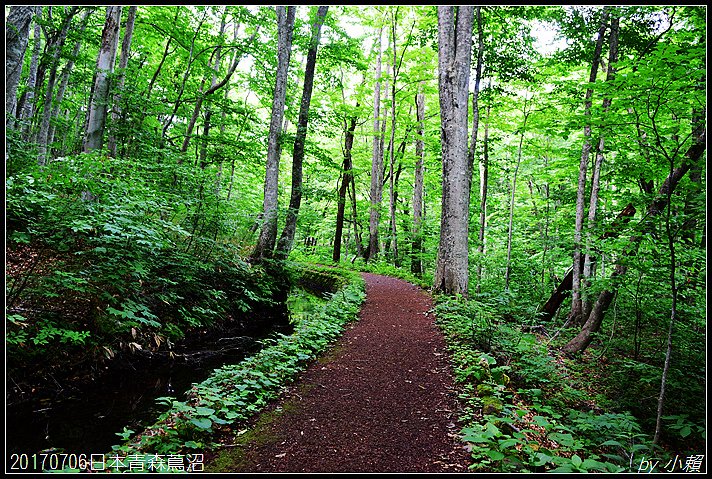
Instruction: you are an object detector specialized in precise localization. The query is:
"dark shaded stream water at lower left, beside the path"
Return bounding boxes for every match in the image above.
[5,337,260,468]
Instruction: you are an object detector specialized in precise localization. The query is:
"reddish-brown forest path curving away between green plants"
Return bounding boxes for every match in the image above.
[213,273,469,472]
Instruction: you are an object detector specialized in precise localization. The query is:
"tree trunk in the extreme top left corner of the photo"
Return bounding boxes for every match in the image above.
[5,5,37,128]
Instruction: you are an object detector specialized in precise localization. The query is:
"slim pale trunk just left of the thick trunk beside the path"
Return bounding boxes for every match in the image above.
[410,82,425,277]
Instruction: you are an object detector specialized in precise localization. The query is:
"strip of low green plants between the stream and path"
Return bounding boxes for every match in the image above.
[79,266,365,470]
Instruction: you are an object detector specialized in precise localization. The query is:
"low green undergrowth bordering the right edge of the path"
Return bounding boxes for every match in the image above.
[436,298,688,473]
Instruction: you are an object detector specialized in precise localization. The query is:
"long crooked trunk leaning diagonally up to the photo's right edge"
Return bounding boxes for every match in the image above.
[563,124,705,354]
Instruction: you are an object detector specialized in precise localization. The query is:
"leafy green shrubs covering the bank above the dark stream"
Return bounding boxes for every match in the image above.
[6,155,277,376]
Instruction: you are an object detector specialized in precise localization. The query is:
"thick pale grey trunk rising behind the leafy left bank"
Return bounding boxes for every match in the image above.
[84,6,122,153]
